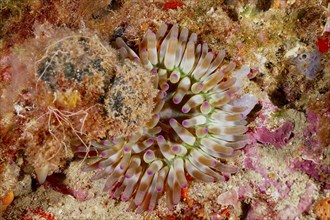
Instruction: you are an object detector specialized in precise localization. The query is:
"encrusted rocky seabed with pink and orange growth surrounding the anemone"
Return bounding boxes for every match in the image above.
[0,0,330,219]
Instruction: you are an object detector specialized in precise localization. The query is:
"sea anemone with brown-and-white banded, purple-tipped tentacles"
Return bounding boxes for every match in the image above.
[78,24,247,212]
